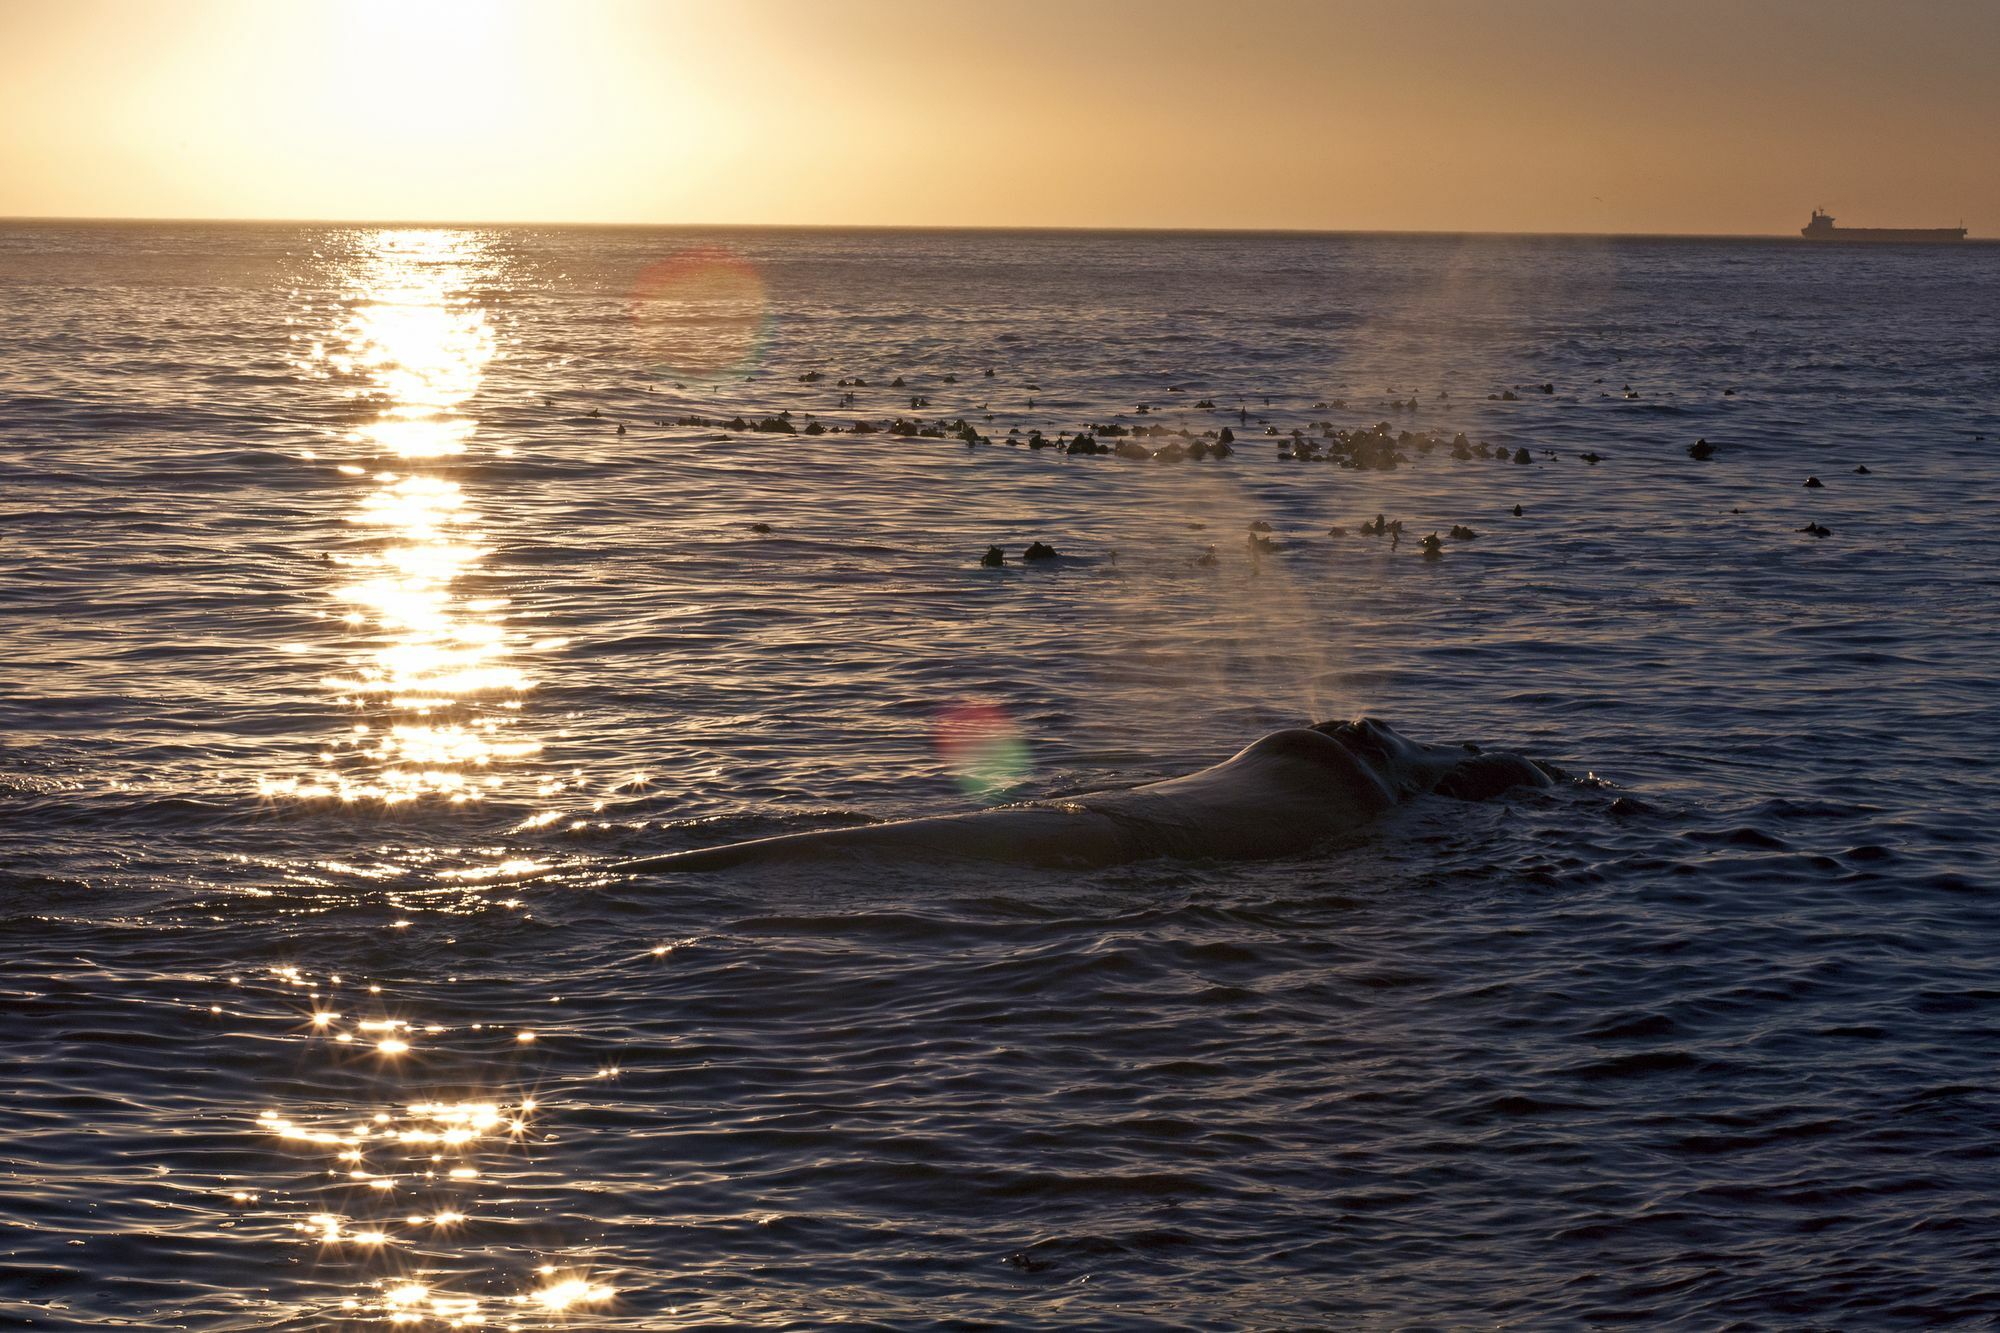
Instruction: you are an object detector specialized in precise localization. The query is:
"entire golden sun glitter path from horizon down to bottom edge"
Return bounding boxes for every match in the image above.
[244,230,614,1329]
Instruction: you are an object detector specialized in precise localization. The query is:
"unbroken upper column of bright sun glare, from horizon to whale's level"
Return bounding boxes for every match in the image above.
[274,230,540,805]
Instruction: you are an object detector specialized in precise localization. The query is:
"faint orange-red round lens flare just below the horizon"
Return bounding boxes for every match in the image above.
[632,246,770,380]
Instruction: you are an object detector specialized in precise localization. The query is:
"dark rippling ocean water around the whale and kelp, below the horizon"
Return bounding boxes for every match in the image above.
[0,224,2000,1329]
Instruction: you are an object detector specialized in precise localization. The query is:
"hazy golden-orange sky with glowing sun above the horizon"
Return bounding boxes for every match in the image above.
[0,0,2000,236]
